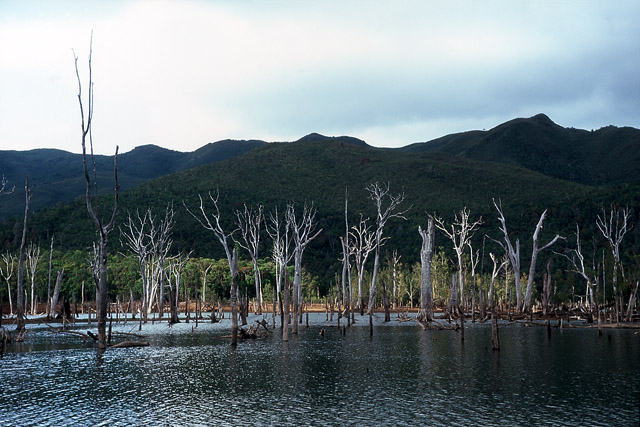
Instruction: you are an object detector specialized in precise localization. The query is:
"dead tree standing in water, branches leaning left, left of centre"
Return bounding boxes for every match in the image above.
[188,192,238,346]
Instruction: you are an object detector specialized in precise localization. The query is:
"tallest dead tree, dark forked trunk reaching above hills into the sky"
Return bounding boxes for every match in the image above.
[73,34,120,349]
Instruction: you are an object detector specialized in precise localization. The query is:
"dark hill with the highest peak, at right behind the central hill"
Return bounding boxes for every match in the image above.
[401,114,640,185]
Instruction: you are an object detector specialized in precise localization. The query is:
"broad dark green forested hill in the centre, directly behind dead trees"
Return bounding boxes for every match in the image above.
[0,124,640,290]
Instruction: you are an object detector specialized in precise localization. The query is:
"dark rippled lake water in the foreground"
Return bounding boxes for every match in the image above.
[0,314,640,426]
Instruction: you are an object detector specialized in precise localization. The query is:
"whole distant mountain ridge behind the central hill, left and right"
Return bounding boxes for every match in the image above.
[0,114,640,219]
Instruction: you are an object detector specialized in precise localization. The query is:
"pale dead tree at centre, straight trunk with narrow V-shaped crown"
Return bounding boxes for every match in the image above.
[287,204,322,334]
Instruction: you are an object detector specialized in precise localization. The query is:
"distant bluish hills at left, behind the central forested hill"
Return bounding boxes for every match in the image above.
[0,140,265,219]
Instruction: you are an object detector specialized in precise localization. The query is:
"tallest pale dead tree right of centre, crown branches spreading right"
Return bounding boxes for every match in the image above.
[365,182,404,315]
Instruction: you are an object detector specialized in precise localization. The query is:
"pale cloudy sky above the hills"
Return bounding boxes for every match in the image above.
[0,0,640,154]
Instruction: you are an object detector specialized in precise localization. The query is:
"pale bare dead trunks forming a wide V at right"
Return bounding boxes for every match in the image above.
[493,200,564,312]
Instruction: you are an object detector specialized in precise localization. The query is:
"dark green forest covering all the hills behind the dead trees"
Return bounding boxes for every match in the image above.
[0,115,640,310]
